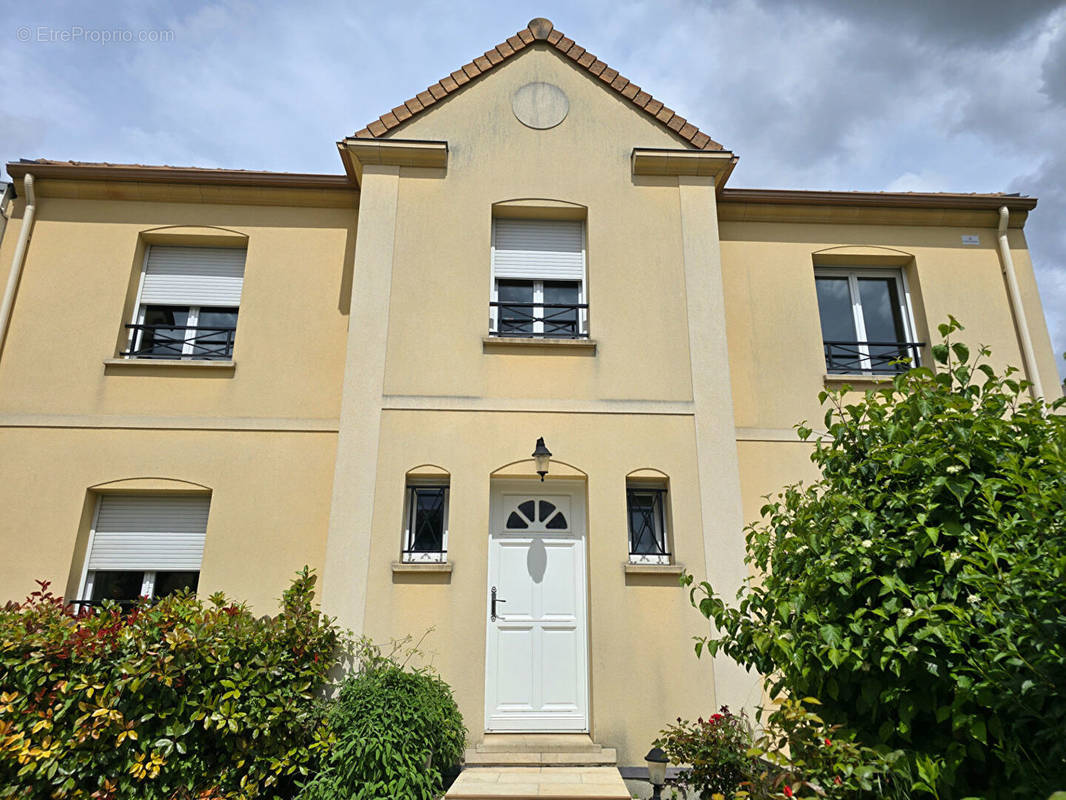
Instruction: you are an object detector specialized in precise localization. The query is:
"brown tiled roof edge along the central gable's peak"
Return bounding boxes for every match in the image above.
[355,17,725,150]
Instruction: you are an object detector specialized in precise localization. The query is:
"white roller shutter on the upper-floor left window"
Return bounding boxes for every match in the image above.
[141,245,247,306]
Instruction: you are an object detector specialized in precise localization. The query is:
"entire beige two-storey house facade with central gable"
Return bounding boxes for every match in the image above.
[0,19,1060,764]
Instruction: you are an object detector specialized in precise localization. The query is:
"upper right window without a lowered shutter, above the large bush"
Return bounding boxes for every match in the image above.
[814,269,921,374]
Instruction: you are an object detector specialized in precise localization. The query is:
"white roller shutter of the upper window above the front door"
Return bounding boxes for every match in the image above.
[492,219,585,281]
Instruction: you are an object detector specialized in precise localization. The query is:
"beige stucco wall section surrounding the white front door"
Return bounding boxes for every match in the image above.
[366,411,714,764]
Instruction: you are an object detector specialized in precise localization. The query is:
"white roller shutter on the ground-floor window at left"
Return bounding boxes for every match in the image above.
[88,495,211,571]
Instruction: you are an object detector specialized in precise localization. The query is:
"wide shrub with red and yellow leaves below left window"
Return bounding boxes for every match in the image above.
[0,567,339,800]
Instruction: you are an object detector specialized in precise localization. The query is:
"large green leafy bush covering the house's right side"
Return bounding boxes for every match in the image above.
[690,320,1066,798]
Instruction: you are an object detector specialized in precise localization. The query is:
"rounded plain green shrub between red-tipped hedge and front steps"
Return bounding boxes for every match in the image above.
[301,640,467,800]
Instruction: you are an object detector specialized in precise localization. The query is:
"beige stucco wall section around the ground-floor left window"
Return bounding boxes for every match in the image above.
[0,428,336,613]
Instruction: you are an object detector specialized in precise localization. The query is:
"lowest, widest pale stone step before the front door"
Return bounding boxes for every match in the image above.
[445,767,632,800]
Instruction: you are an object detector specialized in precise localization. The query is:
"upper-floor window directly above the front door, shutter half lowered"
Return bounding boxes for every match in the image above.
[489,218,588,339]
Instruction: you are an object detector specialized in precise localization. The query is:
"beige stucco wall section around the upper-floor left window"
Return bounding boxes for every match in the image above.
[0,194,355,420]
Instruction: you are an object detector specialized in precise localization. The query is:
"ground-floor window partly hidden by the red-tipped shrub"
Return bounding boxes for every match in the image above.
[78,495,211,604]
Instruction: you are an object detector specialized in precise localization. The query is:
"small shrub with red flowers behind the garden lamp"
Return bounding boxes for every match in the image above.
[656,706,753,798]
